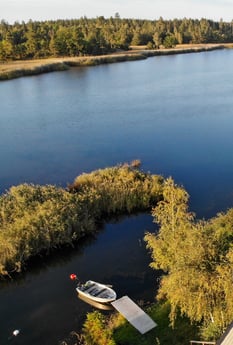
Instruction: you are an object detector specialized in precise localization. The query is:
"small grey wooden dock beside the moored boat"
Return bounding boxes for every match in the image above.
[111,296,157,334]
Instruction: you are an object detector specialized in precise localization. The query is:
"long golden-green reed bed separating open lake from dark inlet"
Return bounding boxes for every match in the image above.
[0,162,163,275]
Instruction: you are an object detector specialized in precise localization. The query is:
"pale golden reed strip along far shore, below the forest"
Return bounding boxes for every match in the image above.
[0,43,230,81]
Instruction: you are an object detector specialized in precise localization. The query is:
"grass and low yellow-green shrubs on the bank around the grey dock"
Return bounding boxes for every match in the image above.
[62,302,199,345]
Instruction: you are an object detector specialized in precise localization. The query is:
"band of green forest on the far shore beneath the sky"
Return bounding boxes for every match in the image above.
[0,15,233,61]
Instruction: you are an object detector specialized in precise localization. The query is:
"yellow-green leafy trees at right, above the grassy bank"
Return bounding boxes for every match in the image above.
[145,179,233,338]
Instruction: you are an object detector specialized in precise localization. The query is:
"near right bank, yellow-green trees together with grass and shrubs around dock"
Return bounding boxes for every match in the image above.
[74,178,233,345]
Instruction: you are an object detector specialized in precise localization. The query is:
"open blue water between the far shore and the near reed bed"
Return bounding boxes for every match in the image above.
[0,50,233,217]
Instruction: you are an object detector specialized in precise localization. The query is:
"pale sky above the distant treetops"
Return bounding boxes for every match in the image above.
[0,0,233,23]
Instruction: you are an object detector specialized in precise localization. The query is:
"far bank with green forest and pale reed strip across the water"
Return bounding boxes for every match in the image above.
[0,15,233,80]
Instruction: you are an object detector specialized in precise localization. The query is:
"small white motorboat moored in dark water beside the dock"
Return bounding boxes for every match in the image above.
[76,280,116,303]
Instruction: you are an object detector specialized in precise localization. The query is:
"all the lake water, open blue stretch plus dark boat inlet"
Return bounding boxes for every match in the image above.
[0,50,233,345]
